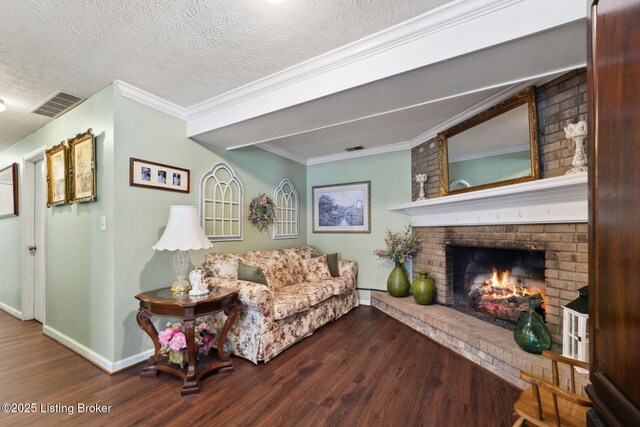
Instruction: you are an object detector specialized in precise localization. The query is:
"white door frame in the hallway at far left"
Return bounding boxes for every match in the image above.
[20,146,47,323]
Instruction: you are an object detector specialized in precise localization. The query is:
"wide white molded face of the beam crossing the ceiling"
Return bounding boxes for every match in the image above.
[186,0,586,137]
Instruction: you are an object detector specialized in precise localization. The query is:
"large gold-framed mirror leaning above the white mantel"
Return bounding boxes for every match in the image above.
[438,88,539,196]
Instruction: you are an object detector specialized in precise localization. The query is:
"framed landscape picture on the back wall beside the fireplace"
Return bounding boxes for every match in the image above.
[312,181,371,233]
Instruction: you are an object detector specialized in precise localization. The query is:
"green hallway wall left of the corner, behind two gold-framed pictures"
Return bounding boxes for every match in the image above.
[0,87,113,359]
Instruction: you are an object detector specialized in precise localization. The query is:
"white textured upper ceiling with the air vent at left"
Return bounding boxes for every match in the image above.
[0,0,451,151]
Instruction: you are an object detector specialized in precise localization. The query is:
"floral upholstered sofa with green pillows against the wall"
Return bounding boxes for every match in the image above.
[202,246,358,363]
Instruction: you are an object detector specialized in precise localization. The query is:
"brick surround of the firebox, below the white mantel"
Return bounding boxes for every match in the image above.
[413,224,588,344]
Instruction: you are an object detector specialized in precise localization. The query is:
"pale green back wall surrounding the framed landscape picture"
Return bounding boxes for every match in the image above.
[307,150,411,300]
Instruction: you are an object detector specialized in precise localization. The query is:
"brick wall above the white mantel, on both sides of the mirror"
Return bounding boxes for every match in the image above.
[411,69,587,200]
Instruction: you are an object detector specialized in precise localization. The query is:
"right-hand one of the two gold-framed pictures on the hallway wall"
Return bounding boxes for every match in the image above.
[69,129,96,203]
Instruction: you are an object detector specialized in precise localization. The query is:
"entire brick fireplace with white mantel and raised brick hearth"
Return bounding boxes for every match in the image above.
[371,69,588,388]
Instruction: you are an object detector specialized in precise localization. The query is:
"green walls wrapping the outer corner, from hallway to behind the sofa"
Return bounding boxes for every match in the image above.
[0,86,307,361]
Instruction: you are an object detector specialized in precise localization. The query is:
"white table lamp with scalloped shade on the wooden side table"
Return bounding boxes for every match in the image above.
[153,206,213,295]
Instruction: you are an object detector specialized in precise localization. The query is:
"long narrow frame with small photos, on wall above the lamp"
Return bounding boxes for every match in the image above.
[129,157,191,193]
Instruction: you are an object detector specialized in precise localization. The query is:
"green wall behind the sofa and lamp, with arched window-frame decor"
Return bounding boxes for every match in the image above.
[113,94,307,360]
